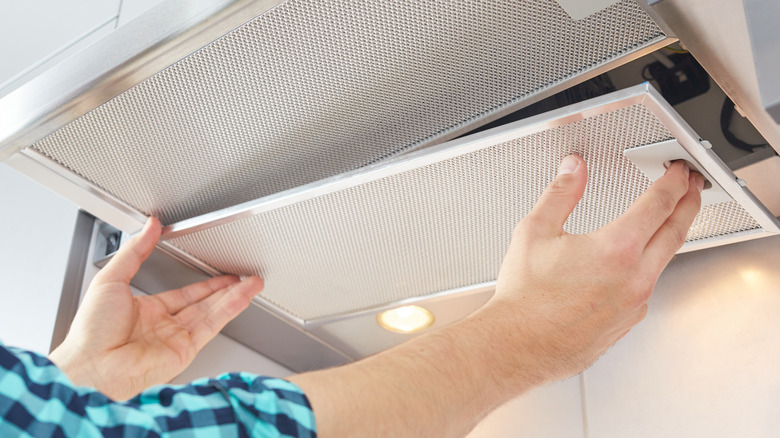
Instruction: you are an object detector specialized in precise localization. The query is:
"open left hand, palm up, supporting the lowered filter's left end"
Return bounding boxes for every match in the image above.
[49,218,263,399]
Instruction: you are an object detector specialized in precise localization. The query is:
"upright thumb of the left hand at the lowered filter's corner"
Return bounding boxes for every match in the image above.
[95,217,162,284]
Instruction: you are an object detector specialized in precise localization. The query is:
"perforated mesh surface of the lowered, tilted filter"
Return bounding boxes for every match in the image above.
[166,105,758,319]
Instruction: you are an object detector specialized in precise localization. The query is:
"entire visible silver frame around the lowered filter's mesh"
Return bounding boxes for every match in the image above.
[163,83,780,326]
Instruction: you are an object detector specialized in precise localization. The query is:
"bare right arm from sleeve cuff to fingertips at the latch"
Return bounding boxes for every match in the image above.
[291,156,703,438]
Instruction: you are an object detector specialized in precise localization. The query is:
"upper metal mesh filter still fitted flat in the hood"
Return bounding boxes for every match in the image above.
[32,0,664,223]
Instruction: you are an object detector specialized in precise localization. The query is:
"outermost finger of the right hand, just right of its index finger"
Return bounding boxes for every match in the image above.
[645,172,704,272]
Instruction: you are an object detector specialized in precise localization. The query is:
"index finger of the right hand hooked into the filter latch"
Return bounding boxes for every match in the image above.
[604,161,690,248]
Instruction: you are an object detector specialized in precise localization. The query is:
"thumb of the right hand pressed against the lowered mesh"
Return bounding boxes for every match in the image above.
[527,155,588,235]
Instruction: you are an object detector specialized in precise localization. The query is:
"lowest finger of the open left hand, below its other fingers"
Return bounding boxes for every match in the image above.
[184,277,264,350]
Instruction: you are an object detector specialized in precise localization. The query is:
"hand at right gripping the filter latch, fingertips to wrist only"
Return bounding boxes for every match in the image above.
[484,155,704,388]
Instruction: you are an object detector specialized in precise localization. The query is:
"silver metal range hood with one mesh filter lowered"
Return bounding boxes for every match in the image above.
[0,0,780,371]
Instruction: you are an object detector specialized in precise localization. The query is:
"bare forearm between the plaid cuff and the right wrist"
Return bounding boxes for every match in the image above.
[290,308,543,438]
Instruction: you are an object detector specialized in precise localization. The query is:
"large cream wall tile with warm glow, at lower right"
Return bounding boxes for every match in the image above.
[585,236,780,438]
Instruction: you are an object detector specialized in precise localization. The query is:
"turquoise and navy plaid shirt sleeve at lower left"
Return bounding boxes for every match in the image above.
[0,344,316,437]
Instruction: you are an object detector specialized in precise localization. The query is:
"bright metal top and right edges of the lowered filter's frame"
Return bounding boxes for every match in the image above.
[163,83,780,240]
